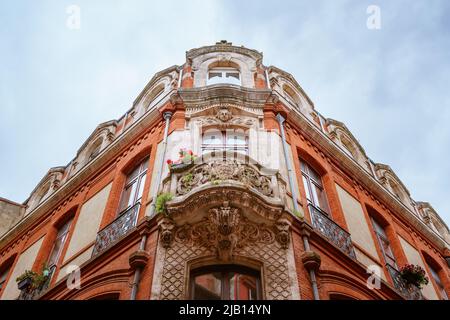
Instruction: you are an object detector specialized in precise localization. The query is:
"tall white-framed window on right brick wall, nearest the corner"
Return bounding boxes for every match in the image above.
[300,160,329,214]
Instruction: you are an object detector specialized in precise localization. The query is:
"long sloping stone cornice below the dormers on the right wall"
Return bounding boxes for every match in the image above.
[288,105,449,250]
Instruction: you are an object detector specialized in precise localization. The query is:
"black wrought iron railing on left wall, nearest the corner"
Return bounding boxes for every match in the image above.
[92,203,141,257]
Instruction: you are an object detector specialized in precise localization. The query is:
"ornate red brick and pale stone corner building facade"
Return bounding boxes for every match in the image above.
[0,41,450,300]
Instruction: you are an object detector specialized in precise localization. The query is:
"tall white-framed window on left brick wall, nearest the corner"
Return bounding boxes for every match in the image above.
[119,157,149,214]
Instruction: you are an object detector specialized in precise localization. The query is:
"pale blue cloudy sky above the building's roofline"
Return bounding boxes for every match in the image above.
[0,0,450,225]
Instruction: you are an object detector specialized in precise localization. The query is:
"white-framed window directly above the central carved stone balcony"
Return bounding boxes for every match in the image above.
[202,129,248,154]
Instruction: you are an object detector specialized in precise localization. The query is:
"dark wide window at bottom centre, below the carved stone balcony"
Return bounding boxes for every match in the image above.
[190,265,262,300]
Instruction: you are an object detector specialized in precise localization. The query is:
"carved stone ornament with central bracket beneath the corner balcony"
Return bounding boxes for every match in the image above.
[160,201,290,261]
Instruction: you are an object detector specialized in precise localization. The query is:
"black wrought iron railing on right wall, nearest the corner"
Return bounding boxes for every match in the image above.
[308,204,356,259]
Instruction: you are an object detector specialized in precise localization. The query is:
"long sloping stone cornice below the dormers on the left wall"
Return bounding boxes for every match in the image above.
[0,95,169,250]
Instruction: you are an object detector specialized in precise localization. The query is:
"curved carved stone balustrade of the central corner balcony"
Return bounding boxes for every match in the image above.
[176,161,273,197]
